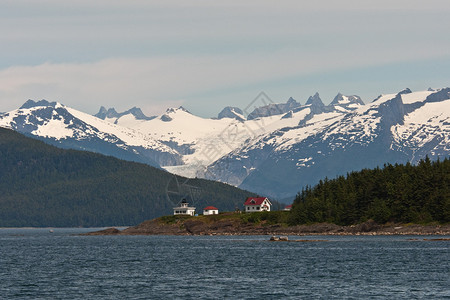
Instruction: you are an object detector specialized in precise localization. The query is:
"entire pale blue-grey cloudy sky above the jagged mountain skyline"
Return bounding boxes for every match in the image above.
[0,0,450,117]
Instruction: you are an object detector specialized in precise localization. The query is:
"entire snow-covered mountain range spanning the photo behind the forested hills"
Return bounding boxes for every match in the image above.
[0,88,450,200]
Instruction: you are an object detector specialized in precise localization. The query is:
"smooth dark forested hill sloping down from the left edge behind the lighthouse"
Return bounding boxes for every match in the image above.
[0,128,254,227]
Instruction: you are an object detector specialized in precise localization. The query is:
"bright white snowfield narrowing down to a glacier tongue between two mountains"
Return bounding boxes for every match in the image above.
[117,107,286,177]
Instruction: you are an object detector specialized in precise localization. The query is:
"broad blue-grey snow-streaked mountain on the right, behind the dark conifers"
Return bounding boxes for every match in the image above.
[206,88,450,198]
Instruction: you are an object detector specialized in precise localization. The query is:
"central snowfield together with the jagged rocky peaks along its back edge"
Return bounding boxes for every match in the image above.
[93,94,364,177]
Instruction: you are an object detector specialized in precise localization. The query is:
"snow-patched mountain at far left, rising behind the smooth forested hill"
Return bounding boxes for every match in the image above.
[0,100,181,167]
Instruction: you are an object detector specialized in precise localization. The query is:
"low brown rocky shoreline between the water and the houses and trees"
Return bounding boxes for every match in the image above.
[83,218,450,236]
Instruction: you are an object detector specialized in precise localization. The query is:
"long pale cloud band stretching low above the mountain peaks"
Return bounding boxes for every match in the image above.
[0,49,446,113]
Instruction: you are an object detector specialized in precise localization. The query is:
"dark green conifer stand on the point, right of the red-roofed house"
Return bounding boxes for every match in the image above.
[290,158,450,225]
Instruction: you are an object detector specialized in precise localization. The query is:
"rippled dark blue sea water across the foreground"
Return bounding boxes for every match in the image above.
[0,229,450,299]
